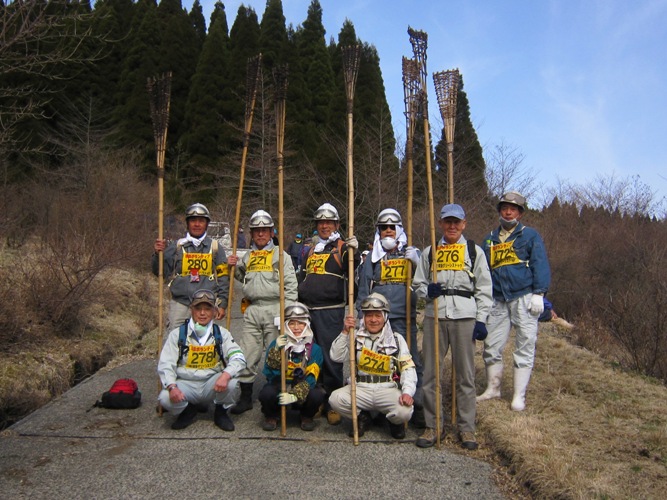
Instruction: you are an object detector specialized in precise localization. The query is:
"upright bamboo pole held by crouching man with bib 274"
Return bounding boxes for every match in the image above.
[343,45,361,446]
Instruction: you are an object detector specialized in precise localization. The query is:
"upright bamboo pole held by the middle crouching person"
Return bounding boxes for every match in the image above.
[273,65,287,437]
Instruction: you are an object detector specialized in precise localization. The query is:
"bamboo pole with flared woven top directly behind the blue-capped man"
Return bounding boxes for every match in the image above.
[433,69,459,426]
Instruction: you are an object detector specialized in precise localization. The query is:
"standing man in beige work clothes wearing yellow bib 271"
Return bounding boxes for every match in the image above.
[228,210,297,414]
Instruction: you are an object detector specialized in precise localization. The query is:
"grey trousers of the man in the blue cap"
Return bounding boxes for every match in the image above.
[422,317,476,432]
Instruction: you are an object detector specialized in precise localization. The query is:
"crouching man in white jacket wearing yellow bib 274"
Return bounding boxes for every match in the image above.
[329,293,417,439]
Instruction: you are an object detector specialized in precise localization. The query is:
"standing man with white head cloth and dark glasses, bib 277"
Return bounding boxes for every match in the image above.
[356,208,425,428]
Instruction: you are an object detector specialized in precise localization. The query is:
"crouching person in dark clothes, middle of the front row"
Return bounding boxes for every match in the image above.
[259,302,326,431]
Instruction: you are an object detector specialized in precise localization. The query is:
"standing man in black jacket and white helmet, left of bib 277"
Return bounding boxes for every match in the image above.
[299,203,360,425]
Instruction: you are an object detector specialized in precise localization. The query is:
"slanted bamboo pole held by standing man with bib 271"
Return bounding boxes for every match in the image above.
[226,54,262,330]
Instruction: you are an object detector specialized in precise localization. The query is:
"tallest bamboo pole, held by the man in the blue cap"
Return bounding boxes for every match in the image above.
[408,28,442,449]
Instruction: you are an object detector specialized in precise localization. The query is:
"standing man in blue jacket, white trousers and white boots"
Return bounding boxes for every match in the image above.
[477,191,551,411]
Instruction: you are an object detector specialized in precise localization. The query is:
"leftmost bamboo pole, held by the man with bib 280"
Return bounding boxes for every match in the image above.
[147,72,171,416]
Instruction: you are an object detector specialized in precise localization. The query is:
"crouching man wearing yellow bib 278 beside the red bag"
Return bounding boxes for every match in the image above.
[158,290,246,431]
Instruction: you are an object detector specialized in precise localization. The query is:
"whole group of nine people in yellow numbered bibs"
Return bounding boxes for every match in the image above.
[153,192,550,450]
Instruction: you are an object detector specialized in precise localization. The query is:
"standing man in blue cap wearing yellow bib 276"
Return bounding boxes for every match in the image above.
[413,203,492,450]
